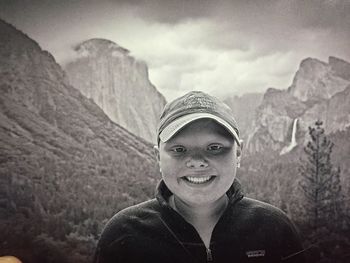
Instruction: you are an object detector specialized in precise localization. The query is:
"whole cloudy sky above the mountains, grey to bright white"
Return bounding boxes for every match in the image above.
[0,0,350,99]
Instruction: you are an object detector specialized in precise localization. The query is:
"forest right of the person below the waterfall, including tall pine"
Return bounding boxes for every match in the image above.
[239,124,350,262]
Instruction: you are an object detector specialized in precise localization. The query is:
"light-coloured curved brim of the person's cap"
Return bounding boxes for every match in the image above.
[159,112,240,145]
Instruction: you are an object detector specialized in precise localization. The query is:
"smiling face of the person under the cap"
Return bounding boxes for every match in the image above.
[158,119,241,206]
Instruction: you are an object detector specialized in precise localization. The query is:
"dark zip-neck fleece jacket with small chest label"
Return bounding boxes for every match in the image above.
[94,180,304,263]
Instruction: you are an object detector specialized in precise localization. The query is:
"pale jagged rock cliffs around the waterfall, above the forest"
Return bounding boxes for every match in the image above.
[246,57,350,153]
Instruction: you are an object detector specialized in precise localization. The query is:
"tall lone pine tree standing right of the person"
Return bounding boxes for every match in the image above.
[299,121,344,240]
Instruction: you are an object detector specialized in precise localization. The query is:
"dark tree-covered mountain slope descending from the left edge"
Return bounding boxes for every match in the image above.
[0,20,159,263]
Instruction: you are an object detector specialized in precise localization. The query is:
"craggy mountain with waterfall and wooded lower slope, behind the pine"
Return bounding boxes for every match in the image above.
[237,57,350,262]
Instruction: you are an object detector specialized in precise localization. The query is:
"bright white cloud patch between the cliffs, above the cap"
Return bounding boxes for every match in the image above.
[115,16,296,99]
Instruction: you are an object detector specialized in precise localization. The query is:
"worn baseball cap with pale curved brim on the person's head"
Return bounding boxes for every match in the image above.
[157,91,240,145]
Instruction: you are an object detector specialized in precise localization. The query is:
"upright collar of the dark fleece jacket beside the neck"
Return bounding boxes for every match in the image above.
[155,178,244,206]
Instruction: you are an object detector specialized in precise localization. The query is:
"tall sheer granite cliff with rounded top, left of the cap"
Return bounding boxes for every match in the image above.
[65,39,165,142]
